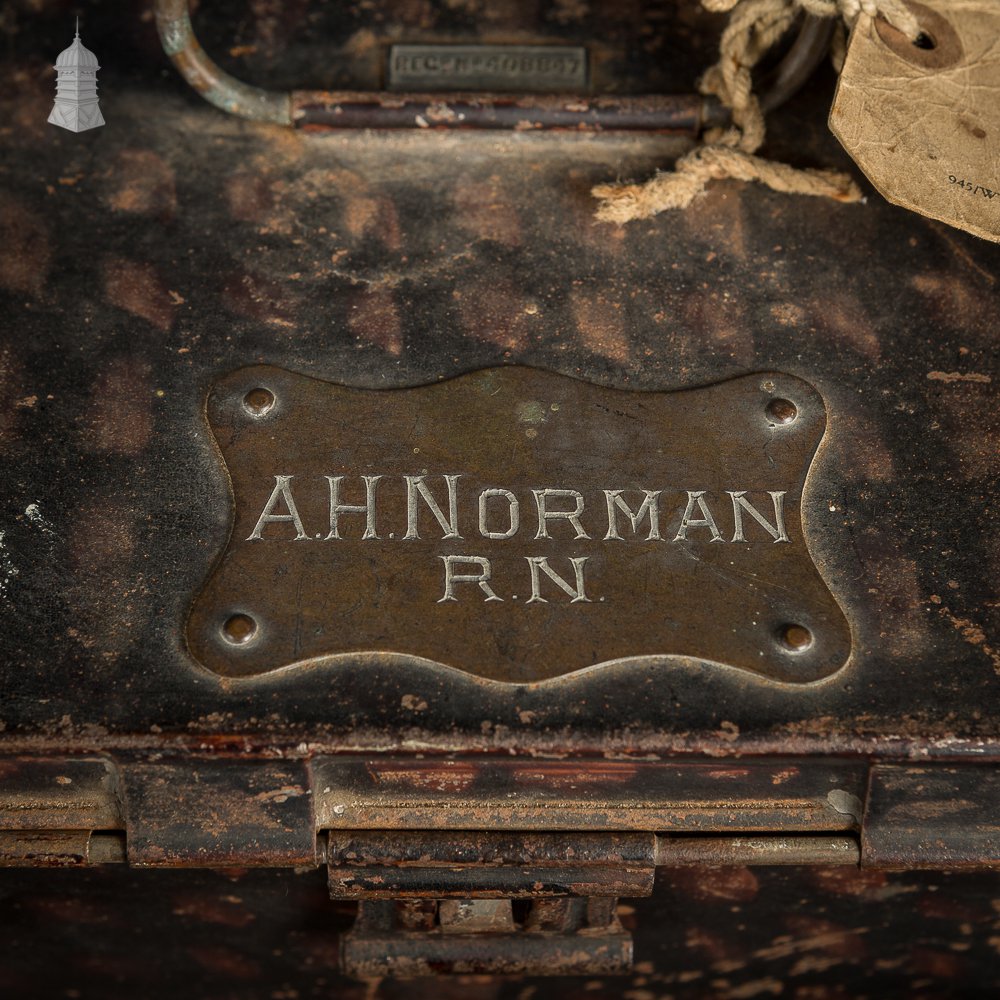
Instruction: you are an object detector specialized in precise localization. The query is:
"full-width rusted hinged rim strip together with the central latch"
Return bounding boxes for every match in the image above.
[0,756,1000,975]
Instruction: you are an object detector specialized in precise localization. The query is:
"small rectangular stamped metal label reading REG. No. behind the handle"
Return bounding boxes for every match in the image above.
[388,45,587,92]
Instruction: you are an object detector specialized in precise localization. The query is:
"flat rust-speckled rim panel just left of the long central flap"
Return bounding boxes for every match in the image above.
[122,758,316,868]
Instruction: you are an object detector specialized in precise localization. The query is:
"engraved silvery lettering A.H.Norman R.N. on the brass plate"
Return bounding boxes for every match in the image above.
[247,473,791,604]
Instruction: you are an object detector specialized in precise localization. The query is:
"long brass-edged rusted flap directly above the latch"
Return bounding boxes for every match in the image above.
[313,757,866,832]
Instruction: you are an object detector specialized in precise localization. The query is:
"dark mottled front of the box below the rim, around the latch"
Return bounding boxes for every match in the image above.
[0,868,1000,1000]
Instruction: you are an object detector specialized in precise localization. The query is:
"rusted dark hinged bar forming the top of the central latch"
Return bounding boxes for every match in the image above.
[327,830,656,899]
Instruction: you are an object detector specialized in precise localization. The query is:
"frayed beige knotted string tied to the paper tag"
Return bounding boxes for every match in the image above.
[591,0,920,225]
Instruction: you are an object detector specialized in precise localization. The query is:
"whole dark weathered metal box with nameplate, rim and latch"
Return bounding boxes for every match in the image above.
[0,0,1000,1000]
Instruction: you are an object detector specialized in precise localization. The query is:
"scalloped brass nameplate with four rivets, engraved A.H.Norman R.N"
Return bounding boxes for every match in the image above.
[187,367,851,683]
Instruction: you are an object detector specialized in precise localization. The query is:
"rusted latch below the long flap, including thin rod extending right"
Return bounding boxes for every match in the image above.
[327,831,858,977]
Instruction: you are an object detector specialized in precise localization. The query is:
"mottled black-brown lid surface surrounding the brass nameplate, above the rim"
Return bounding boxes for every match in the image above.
[0,2,1000,755]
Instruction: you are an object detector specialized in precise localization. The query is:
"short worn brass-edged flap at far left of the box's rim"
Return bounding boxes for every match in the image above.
[0,756,124,831]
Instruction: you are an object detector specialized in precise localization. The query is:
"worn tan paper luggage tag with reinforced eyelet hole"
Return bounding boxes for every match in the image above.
[830,0,1000,241]
